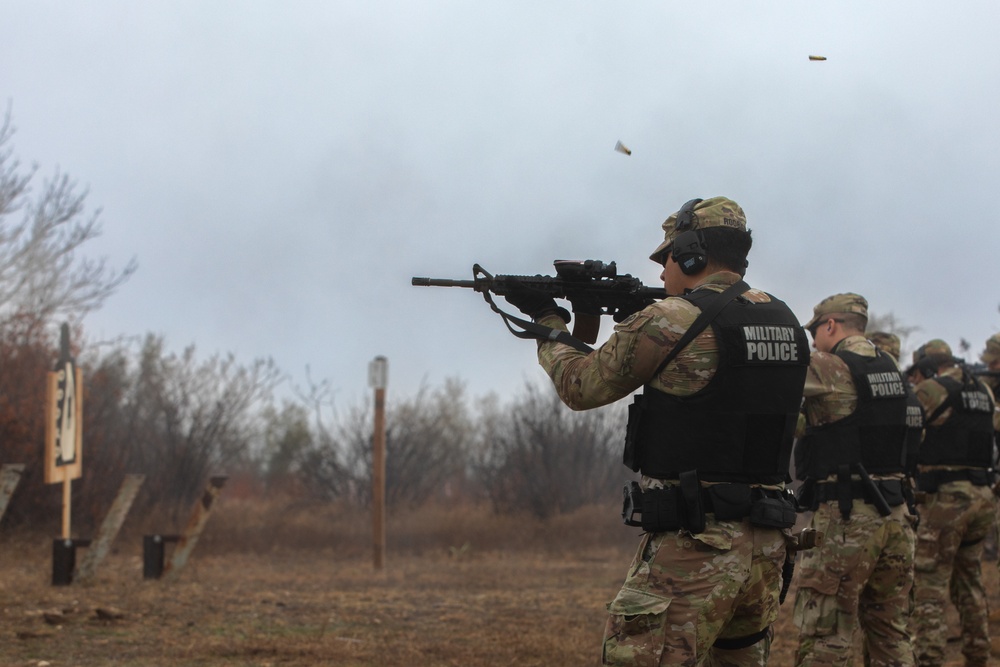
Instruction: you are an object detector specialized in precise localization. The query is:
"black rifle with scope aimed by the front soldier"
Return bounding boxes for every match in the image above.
[410,259,667,352]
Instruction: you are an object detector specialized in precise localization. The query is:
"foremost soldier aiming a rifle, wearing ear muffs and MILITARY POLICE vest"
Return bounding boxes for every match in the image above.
[506,197,809,667]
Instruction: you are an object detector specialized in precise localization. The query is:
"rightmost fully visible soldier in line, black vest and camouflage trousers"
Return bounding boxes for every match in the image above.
[907,339,1000,667]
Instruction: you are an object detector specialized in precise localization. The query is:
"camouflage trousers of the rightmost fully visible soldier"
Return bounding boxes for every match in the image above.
[910,481,995,665]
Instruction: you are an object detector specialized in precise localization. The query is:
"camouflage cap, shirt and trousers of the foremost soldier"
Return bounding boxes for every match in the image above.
[538,198,800,667]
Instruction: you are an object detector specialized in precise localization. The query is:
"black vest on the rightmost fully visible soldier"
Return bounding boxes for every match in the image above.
[917,371,993,468]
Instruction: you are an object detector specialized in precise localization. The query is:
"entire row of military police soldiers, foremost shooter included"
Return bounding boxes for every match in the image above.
[505,197,1000,667]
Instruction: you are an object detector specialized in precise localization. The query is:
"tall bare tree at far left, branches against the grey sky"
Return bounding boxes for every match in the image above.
[0,106,137,332]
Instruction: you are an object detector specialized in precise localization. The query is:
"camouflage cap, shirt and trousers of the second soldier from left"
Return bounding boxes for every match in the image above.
[793,294,914,667]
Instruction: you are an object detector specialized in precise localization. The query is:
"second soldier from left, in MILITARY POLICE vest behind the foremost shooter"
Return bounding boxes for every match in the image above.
[793,293,914,667]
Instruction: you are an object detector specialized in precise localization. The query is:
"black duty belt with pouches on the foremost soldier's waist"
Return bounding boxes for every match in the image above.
[622,481,795,533]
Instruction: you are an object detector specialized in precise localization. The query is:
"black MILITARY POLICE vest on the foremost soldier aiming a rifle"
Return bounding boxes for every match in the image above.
[624,290,809,484]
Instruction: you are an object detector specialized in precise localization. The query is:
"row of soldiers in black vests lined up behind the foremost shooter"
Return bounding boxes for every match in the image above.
[794,300,1000,666]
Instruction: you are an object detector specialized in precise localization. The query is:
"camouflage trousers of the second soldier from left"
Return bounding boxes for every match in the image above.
[793,500,914,667]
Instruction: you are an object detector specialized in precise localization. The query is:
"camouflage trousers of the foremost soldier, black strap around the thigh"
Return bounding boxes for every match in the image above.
[602,519,785,667]
